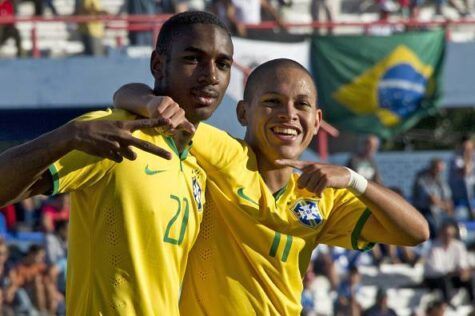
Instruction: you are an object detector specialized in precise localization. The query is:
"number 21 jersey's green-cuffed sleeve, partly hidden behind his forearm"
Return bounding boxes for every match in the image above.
[49,110,127,195]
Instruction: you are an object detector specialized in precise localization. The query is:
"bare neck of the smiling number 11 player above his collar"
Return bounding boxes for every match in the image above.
[255,151,292,193]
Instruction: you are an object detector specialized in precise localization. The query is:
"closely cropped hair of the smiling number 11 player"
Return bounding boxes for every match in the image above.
[244,58,316,102]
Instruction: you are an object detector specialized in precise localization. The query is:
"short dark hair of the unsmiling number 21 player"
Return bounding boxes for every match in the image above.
[155,11,231,55]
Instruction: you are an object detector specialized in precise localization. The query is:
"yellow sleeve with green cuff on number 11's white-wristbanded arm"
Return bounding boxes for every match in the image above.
[317,189,374,251]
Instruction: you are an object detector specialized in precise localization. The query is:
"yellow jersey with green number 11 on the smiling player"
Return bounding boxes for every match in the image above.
[180,123,370,315]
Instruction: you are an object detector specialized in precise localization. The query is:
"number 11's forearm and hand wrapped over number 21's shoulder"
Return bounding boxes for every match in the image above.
[113,83,195,135]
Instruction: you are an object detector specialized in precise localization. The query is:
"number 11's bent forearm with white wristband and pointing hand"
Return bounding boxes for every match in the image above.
[277,160,429,246]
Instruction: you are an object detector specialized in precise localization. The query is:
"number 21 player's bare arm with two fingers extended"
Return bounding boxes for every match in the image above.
[0,119,175,206]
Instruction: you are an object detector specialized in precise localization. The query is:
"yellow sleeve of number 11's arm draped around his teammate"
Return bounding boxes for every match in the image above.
[191,123,248,172]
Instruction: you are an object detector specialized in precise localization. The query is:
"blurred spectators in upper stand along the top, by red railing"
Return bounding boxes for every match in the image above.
[0,0,473,57]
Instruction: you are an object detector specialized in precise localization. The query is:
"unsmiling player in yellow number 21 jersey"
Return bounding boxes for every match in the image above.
[0,12,233,316]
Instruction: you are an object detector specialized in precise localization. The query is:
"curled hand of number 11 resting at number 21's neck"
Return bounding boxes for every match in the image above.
[146,96,195,136]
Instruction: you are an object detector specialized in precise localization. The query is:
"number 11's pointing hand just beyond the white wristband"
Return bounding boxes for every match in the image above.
[276,159,350,196]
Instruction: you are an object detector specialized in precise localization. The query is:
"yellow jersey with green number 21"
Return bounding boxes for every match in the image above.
[50,110,206,316]
